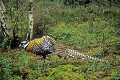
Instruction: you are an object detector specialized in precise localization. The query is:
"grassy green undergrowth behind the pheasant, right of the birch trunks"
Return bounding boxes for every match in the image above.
[34,0,120,54]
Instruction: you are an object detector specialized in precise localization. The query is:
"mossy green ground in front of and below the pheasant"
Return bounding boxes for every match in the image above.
[0,50,120,80]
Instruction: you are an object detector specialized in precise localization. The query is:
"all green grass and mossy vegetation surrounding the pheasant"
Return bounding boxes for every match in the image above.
[0,0,120,80]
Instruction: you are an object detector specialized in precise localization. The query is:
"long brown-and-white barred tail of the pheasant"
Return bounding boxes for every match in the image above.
[45,37,107,62]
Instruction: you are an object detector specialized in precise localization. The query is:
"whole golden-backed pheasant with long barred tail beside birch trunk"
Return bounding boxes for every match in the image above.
[21,36,107,62]
